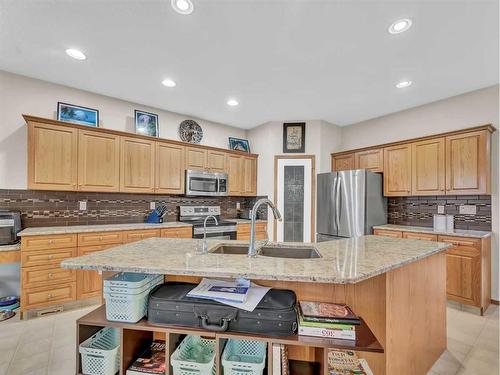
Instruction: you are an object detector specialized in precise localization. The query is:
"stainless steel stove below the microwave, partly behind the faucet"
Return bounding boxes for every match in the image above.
[179,206,236,240]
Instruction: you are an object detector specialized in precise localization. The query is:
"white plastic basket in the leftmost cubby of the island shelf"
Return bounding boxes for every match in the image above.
[79,327,120,375]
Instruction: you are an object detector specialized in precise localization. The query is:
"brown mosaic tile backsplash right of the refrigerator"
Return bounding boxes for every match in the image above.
[387,195,491,231]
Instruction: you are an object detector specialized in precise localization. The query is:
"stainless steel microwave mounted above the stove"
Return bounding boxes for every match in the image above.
[185,169,228,197]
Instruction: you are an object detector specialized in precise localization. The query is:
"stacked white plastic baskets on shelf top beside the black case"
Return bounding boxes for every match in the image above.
[104,275,163,323]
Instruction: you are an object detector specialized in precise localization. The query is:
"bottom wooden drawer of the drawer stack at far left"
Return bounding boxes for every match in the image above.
[21,283,76,310]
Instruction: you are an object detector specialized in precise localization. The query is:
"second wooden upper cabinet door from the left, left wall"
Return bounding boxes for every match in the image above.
[78,130,120,191]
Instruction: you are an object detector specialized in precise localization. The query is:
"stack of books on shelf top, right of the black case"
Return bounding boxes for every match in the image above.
[299,301,360,340]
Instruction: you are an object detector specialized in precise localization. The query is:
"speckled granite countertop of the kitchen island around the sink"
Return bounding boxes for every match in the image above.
[61,236,451,284]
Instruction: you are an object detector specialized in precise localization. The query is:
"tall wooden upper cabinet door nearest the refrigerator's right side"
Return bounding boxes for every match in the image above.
[384,144,411,197]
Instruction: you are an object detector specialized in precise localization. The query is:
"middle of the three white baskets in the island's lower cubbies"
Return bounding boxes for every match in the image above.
[170,335,215,375]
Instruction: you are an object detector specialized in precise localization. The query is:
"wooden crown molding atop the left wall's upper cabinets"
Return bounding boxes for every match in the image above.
[22,114,259,158]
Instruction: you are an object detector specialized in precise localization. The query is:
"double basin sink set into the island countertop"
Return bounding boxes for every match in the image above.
[210,244,321,259]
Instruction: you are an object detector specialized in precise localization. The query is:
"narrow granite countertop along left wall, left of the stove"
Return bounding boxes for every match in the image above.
[18,221,191,236]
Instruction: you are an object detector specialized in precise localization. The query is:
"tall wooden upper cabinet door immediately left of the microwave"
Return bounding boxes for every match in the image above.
[155,142,186,194]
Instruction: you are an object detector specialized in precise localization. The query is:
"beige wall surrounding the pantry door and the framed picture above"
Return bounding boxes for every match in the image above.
[247,120,341,238]
